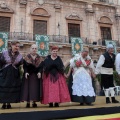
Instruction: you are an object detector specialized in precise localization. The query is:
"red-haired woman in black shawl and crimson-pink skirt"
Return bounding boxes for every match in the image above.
[42,46,70,107]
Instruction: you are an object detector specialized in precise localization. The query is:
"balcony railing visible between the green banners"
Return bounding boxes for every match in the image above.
[5,32,120,46]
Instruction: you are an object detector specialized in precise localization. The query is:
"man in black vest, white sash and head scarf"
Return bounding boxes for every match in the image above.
[95,44,119,103]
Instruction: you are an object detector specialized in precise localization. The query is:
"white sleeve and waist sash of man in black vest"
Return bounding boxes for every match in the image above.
[95,55,113,75]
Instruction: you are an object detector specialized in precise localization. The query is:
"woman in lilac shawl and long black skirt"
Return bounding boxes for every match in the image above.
[0,41,23,109]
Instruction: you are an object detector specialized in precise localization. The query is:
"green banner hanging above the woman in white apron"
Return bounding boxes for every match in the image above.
[71,37,83,55]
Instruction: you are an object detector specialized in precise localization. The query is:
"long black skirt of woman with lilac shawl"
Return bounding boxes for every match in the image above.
[0,65,21,103]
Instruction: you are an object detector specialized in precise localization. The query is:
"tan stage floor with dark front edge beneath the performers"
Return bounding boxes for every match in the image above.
[0,96,120,120]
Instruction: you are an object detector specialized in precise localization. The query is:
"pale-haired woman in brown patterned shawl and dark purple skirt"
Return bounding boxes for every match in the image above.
[21,44,42,108]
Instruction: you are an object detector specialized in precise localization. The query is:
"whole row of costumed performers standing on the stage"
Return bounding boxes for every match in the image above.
[0,41,120,109]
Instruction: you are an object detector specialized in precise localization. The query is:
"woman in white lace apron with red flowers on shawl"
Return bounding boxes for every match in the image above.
[67,51,95,105]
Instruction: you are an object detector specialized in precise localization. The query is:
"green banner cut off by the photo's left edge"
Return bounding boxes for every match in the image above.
[0,32,8,52]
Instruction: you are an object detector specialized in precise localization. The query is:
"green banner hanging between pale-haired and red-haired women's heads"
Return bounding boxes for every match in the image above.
[35,35,49,56]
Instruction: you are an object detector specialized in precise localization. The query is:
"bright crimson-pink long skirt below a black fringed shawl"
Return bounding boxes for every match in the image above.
[42,74,71,104]
